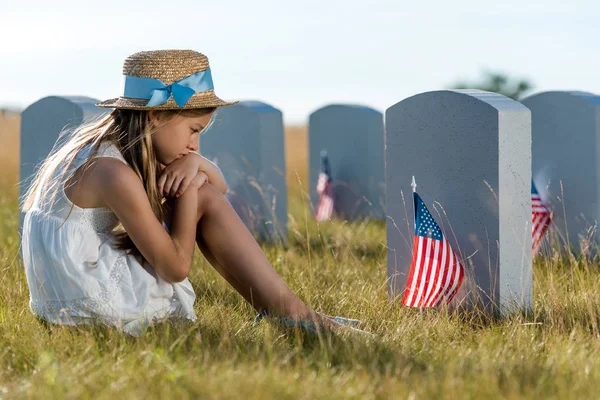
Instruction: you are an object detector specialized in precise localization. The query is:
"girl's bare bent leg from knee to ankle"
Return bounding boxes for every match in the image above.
[197,184,322,320]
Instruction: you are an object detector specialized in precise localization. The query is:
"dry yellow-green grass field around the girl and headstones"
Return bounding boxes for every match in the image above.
[0,114,600,399]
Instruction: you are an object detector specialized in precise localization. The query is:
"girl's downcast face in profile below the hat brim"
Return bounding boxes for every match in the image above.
[150,114,212,165]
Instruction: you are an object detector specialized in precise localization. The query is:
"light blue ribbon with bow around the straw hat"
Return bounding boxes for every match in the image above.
[123,68,214,108]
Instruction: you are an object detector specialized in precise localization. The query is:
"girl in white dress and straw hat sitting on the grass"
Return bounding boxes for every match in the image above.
[22,50,364,335]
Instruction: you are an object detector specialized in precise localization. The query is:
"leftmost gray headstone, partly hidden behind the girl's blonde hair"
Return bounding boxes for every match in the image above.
[19,96,107,229]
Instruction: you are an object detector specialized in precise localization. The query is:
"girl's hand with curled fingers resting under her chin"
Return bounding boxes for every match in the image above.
[158,153,208,197]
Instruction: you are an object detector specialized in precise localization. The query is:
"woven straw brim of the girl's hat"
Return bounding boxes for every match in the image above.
[96,90,238,110]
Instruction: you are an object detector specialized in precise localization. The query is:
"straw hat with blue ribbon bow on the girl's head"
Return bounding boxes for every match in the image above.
[96,50,237,110]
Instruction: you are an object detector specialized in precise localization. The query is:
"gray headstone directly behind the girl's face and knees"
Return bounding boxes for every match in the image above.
[200,101,287,242]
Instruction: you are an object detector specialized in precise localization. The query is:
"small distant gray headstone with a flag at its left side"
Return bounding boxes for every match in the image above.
[308,105,385,219]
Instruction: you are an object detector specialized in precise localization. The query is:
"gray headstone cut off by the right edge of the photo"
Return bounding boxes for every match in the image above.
[522,92,600,250]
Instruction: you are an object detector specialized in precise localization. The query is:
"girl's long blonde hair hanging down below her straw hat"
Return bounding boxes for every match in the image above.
[21,108,215,255]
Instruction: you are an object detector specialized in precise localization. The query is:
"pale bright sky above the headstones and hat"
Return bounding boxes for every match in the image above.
[0,0,600,124]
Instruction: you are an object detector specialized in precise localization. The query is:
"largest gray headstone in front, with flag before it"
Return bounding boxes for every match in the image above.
[385,90,532,312]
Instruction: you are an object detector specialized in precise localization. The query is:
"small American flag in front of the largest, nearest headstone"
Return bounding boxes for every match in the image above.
[402,192,465,307]
